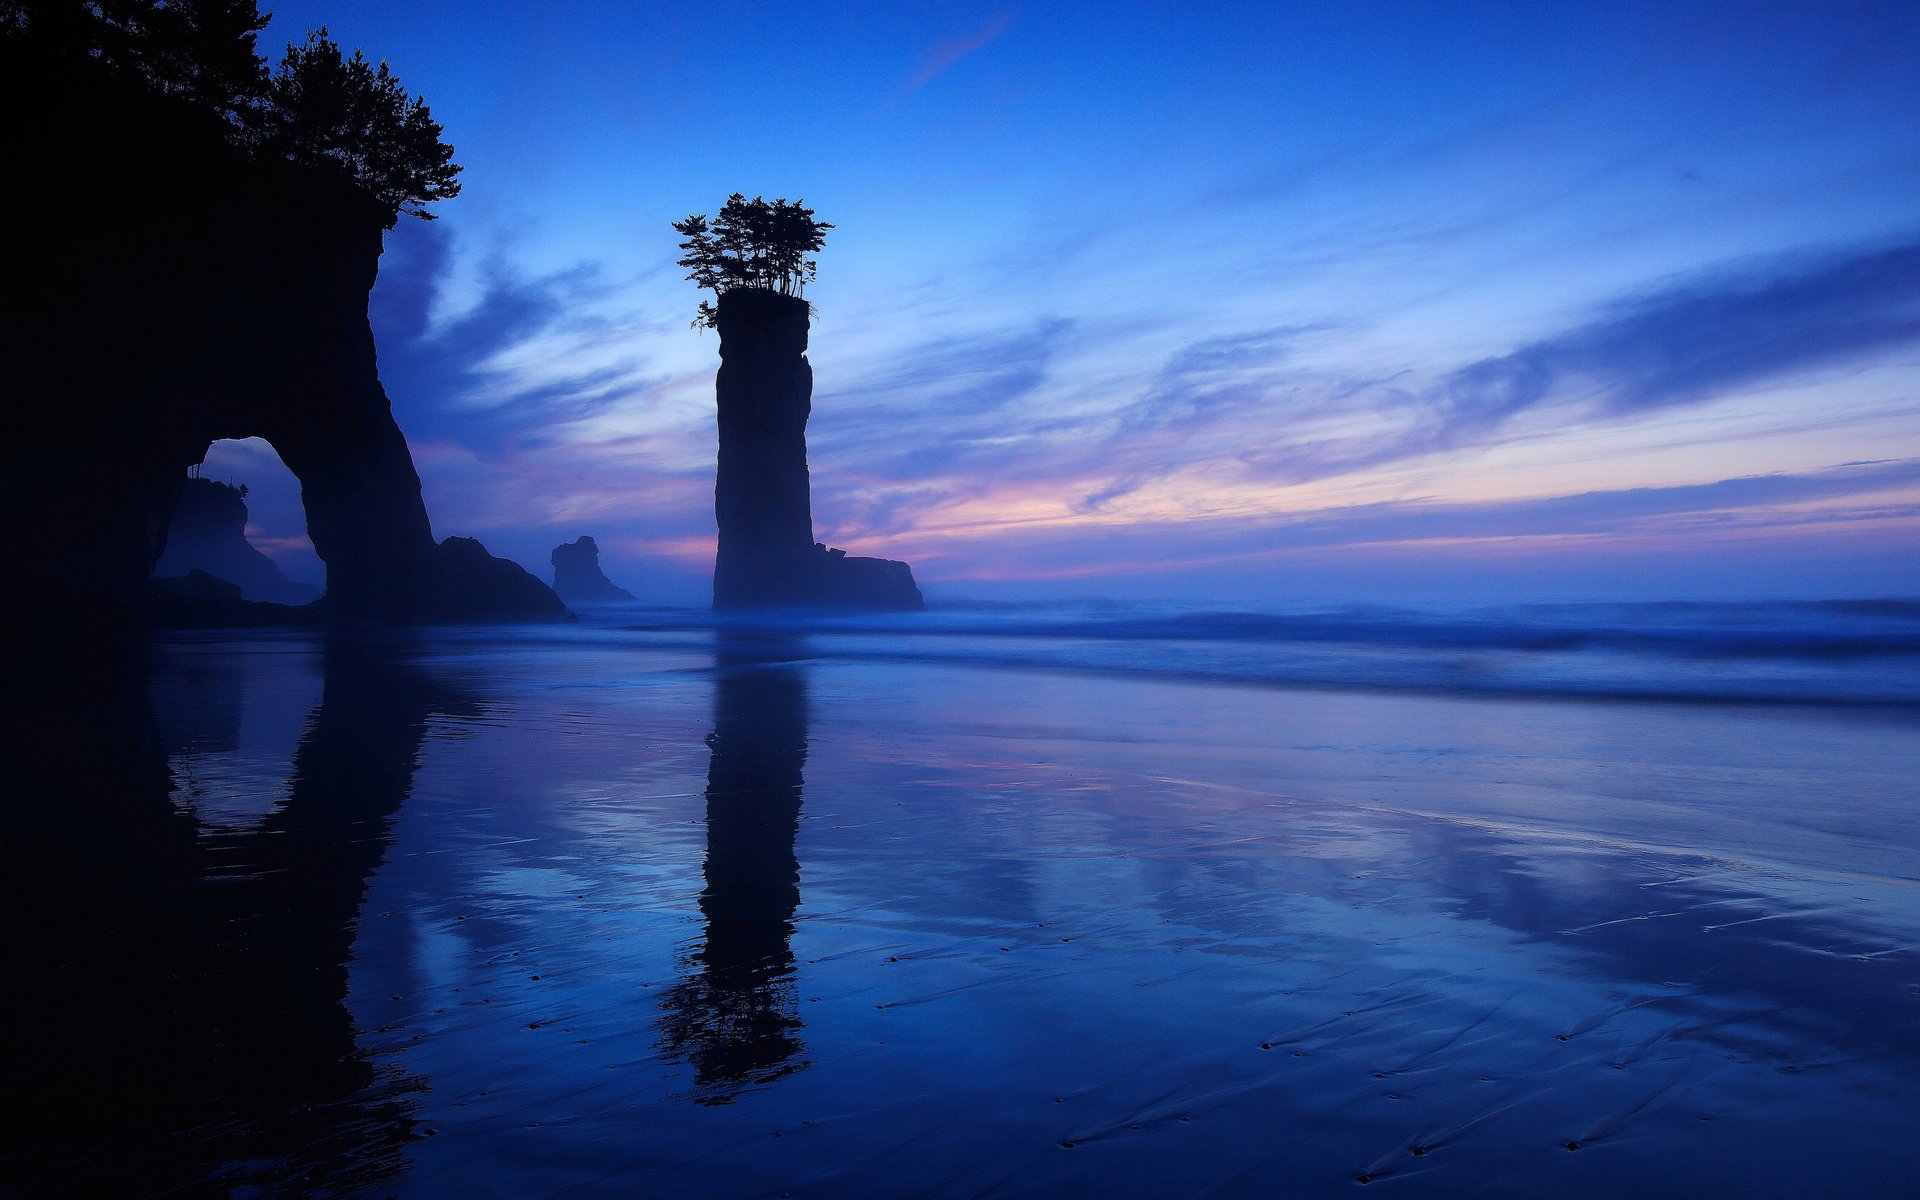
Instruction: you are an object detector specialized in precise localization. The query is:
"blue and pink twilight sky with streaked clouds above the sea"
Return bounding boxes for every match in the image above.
[207,0,1920,603]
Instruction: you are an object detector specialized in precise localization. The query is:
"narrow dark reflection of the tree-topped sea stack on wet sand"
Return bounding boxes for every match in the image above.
[660,648,806,1104]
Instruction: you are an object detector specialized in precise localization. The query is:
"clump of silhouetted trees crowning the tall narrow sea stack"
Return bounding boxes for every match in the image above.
[674,192,833,326]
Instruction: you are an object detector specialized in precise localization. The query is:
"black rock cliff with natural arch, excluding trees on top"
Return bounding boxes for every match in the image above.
[0,58,560,624]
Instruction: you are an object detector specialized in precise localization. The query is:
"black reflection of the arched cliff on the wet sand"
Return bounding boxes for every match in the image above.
[0,647,456,1196]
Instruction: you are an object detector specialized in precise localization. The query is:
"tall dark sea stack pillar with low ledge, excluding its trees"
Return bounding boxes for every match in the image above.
[714,288,925,609]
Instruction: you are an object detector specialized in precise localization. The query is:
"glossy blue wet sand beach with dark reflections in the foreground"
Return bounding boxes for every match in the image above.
[8,630,1920,1196]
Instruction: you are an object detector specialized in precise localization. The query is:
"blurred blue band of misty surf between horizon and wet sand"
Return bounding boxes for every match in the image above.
[586,599,1920,707]
